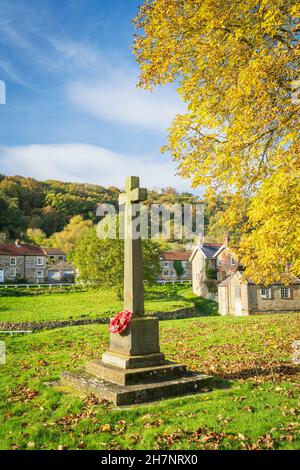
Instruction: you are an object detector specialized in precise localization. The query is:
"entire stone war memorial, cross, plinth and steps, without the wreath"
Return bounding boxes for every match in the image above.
[61,176,212,406]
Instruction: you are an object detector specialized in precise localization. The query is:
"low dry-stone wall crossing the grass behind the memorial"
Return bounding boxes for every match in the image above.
[0,307,195,331]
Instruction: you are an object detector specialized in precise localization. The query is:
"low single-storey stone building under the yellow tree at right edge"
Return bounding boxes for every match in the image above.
[218,271,300,316]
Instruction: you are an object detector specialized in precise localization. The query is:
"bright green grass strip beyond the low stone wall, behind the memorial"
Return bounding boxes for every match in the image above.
[0,285,193,322]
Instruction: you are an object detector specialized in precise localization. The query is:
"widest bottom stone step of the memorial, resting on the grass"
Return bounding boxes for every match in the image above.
[61,372,214,406]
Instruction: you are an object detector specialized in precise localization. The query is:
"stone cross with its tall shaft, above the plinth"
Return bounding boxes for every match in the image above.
[120,176,147,316]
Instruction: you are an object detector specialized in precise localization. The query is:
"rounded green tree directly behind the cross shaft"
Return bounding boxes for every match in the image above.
[72,216,161,298]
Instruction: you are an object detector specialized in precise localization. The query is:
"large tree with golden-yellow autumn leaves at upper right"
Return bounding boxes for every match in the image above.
[134,0,300,283]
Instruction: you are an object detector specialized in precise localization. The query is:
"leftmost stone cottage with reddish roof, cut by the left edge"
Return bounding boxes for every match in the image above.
[0,240,47,284]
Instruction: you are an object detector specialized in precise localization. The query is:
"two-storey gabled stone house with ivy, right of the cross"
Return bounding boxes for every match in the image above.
[190,239,239,298]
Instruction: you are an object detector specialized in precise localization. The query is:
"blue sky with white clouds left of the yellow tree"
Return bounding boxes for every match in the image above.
[0,0,197,192]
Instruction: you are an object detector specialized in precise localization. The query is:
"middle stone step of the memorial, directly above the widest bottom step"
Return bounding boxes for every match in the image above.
[86,361,186,386]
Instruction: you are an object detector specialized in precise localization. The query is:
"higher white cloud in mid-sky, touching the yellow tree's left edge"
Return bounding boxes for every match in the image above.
[67,67,185,132]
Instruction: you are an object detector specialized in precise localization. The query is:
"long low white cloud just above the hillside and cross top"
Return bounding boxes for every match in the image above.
[0,144,190,191]
